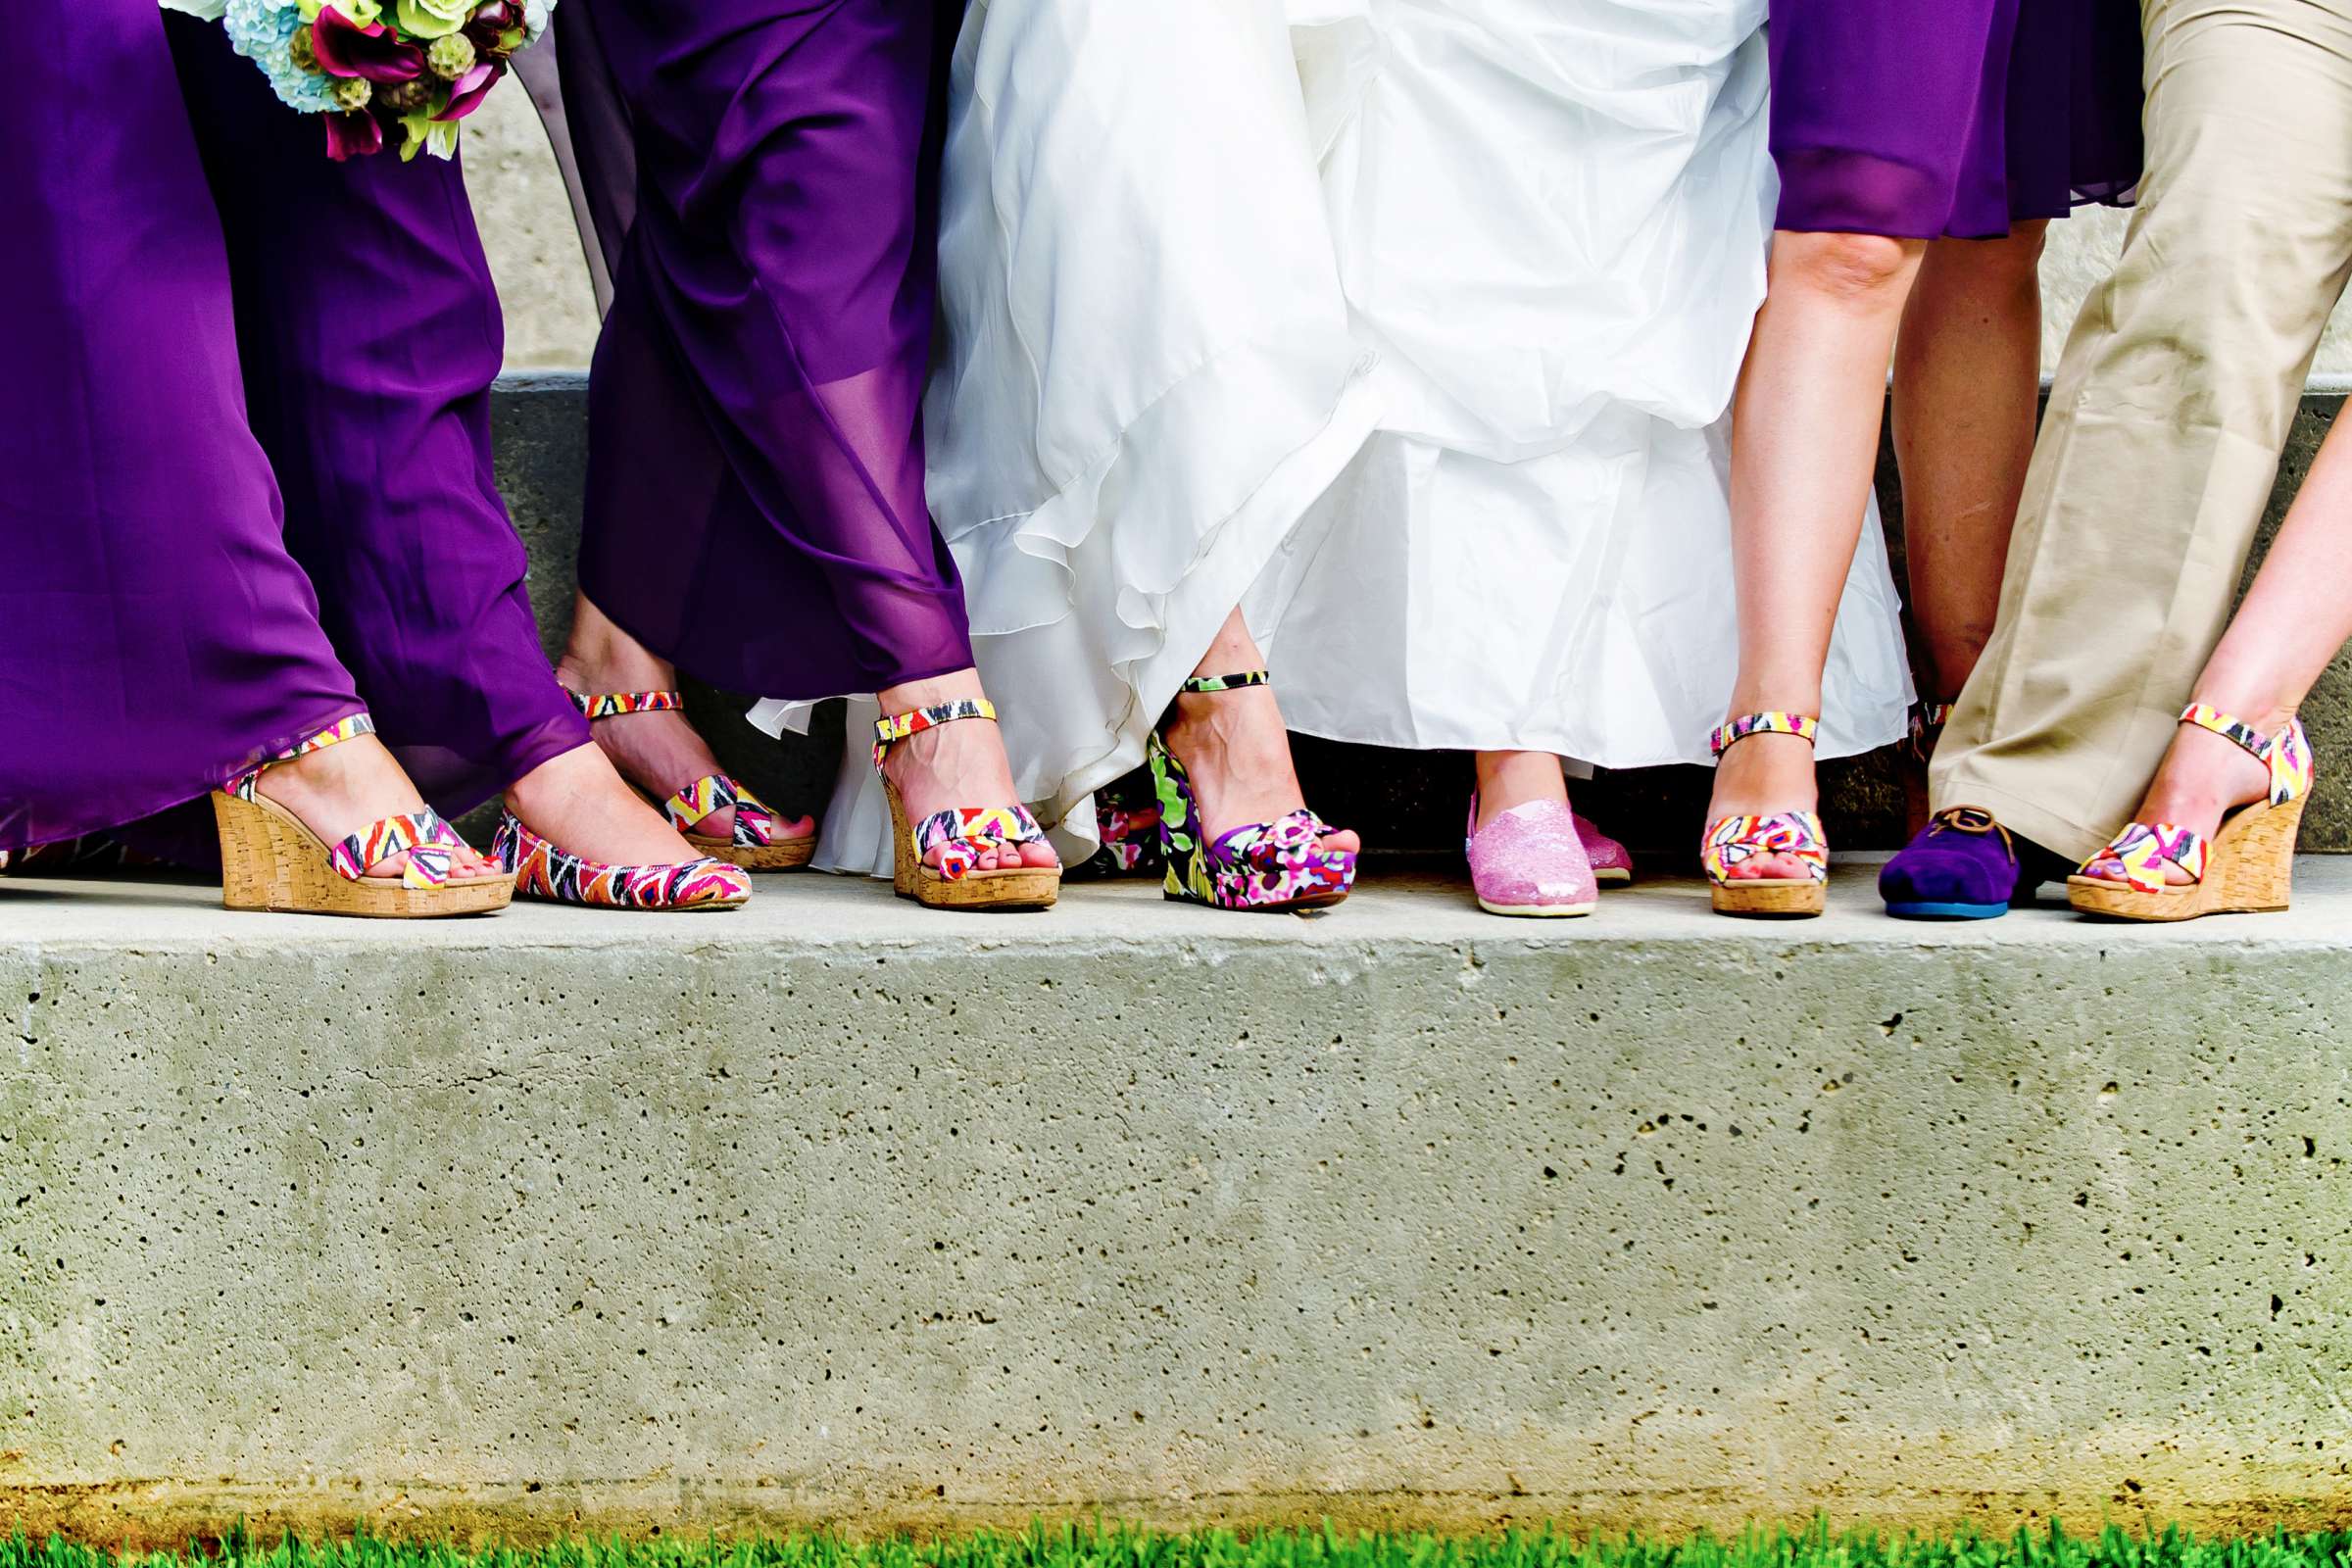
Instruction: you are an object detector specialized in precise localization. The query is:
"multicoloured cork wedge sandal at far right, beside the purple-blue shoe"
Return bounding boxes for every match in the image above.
[2065,703,2312,921]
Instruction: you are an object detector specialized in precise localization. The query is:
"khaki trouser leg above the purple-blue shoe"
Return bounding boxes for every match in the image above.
[1931,0,2352,860]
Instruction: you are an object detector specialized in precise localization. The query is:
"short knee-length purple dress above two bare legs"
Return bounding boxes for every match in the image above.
[1771,0,2140,240]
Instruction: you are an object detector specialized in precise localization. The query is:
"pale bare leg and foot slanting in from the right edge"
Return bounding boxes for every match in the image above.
[2091,414,2352,882]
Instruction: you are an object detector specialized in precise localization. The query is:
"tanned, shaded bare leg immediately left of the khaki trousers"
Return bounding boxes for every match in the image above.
[1895,223,2048,703]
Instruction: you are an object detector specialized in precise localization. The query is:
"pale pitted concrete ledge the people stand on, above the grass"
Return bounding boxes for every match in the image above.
[0,860,2352,1538]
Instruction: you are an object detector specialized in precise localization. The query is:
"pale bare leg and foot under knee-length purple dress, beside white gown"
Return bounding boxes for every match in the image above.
[1707,230,1927,877]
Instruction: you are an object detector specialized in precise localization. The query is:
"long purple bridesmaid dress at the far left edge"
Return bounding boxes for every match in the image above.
[0,0,363,849]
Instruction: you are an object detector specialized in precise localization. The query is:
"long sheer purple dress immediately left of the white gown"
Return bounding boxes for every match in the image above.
[555,0,971,698]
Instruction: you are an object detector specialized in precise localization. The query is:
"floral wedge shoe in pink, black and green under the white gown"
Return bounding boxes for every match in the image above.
[1151,670,1354,912]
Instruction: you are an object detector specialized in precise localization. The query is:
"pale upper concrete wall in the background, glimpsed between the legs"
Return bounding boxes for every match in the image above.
[466,89,2352,376]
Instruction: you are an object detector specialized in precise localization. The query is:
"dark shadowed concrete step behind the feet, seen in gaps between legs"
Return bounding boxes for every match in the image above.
[482,376,2352,860]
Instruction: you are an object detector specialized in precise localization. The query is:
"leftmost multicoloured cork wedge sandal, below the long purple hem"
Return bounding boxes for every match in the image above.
[212,712,515,919]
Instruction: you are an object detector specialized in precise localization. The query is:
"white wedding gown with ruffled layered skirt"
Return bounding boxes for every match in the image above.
[755,0,1910,874]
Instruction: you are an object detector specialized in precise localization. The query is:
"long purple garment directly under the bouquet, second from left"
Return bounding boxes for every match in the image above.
[170,17,588,815]
